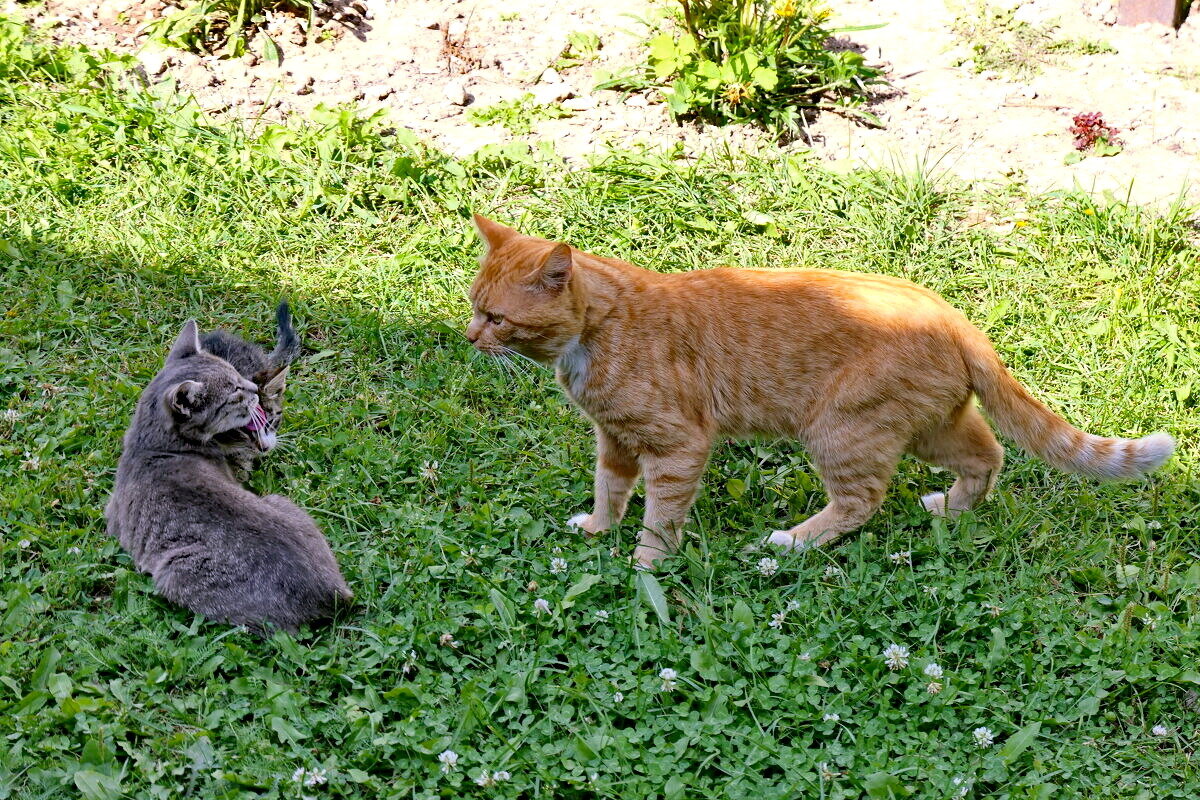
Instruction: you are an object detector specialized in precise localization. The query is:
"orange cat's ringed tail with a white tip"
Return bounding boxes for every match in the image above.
[962,336,1175,479]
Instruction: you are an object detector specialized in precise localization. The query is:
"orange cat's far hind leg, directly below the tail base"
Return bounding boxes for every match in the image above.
[908,401,1004,517]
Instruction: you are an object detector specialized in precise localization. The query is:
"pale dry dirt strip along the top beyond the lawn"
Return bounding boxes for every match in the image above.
[9,0,1200,201]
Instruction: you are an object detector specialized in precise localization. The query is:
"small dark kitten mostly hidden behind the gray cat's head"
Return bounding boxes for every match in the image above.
[200,300,300,481]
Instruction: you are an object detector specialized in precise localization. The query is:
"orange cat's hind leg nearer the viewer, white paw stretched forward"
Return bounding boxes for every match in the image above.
[764,431,904,549]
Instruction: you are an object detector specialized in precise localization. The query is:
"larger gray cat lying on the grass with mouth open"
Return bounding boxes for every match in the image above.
[104,321,352,632]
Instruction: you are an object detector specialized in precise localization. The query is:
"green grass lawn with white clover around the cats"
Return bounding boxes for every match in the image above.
[0,15,1200,800]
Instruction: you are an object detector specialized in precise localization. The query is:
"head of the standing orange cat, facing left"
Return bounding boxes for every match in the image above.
[467,213,584,363]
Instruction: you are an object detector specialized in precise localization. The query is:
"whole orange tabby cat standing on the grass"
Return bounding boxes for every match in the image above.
[467,215,1175,566]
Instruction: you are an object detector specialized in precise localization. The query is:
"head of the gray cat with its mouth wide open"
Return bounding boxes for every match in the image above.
[155,320,274,450]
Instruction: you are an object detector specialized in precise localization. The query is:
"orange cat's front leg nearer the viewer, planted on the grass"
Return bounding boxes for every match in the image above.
[634,441,710,569]
